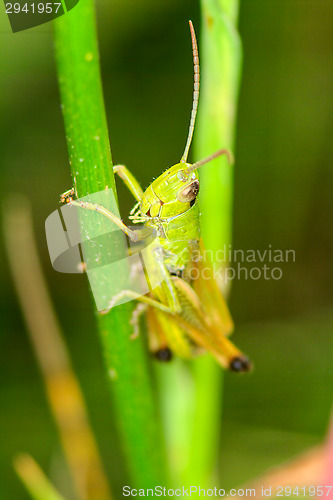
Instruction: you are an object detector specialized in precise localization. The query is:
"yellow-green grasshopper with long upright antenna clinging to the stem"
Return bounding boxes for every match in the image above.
[61,21,251,372]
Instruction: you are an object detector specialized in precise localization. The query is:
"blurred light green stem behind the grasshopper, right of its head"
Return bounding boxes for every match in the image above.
[189,0,241,485]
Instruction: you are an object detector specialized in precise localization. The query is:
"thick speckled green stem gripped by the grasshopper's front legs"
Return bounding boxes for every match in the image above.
[55,0,166,488]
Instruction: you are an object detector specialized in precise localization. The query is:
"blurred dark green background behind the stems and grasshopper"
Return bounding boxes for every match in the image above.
[0,0,333,500]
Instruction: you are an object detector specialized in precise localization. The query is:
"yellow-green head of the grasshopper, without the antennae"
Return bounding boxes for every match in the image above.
[140,163,199,219]
